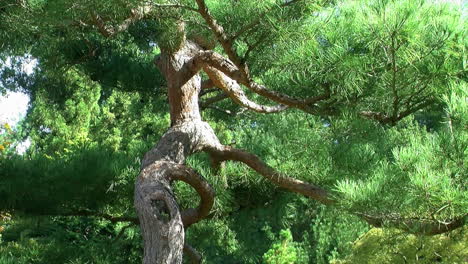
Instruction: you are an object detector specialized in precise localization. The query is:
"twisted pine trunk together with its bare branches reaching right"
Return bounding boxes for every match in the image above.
[135,40,332,264]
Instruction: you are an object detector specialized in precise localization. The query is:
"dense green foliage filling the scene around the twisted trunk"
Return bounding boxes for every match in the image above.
[0,0,468,264]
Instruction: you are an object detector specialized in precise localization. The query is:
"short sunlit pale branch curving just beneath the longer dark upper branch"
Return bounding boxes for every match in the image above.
[203,66,288,113]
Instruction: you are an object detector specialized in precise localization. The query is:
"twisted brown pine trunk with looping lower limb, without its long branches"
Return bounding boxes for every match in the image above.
[135,42,219,264]
